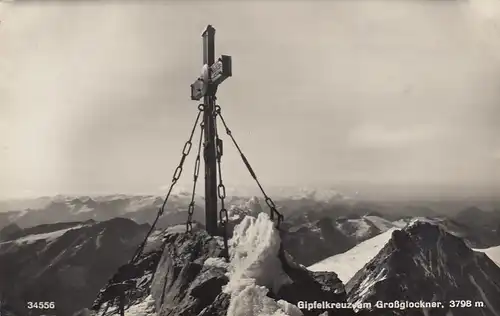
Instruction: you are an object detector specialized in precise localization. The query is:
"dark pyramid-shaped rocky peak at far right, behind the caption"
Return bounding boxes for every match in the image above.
[346,220,500,316]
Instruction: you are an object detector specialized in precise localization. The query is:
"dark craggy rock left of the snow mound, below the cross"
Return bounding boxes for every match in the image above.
[94,229,227,316]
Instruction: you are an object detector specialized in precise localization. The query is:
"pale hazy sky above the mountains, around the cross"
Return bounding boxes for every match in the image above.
[0,0,500,197]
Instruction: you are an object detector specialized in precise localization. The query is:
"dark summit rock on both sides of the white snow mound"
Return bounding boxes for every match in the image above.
[94,218,352,316]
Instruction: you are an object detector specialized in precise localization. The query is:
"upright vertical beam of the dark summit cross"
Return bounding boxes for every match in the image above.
[202,25,217,236]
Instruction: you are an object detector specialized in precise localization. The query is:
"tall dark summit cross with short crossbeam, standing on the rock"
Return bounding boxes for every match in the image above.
[191,25,232,236]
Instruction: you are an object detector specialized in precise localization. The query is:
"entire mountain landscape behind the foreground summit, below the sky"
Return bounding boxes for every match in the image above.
[0,194,500,316]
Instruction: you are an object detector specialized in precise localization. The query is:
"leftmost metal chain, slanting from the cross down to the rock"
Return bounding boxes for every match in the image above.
[130,104,205,263]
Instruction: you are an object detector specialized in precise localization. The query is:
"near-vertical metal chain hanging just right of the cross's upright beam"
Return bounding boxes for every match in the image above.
[214,112,229,262]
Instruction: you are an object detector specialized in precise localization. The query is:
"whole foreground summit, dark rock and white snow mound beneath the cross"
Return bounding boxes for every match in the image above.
[84,213,352,316]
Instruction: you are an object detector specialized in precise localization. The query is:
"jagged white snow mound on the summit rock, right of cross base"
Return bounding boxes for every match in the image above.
[224,213,302,316]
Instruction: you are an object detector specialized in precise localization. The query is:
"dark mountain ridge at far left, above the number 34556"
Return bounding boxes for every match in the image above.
[0,218,149,316]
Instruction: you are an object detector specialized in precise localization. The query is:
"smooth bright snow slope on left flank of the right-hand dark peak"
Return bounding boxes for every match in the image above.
[308,228,396,284]
